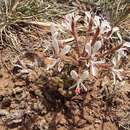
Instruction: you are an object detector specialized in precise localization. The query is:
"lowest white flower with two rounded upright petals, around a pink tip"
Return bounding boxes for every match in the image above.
[70,70,89,91]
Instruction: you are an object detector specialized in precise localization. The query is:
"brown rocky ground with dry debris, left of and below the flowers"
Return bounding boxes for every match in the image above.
[0,0,130,130]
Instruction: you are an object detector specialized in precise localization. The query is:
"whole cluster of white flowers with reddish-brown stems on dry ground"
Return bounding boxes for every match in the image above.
[42,11,130,94]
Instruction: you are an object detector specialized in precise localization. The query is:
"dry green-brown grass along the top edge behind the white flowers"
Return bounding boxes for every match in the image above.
[0,0,128,49]
